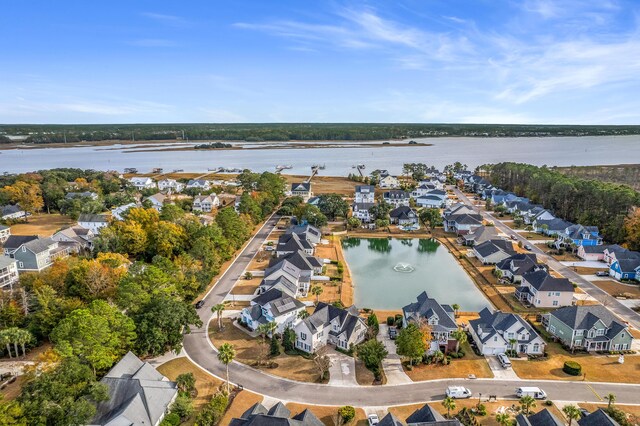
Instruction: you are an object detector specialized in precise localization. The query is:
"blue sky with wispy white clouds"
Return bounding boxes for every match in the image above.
[0,0,640,124]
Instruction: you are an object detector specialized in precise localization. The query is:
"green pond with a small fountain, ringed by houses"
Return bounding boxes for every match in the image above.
[342,238,491,312]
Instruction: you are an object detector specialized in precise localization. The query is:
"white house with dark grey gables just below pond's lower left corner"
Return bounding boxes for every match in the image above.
[295,302,367,353]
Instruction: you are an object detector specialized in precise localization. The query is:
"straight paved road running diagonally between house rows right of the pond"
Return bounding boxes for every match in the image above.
[453,188,640,330]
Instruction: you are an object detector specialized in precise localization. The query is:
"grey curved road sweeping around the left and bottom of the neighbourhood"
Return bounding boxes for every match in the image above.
[184,216,640,407]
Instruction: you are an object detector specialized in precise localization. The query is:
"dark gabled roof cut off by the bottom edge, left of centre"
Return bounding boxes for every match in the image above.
[229,402,324,426]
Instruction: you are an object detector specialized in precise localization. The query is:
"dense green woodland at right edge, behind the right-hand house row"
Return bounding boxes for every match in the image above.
[482,163,640,243]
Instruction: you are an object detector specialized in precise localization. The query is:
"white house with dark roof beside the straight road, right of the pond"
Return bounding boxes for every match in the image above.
[515,269,573,308]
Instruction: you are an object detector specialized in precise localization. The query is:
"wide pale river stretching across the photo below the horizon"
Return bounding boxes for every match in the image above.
[0,135,640,176]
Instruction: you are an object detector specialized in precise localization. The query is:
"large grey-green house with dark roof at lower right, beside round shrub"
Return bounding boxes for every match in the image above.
[543,305,633,352]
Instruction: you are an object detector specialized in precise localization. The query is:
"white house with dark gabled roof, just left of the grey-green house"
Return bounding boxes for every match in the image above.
[469,308,545,355]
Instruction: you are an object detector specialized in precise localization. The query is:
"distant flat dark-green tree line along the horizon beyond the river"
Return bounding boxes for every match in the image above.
[0,123,640,143]
